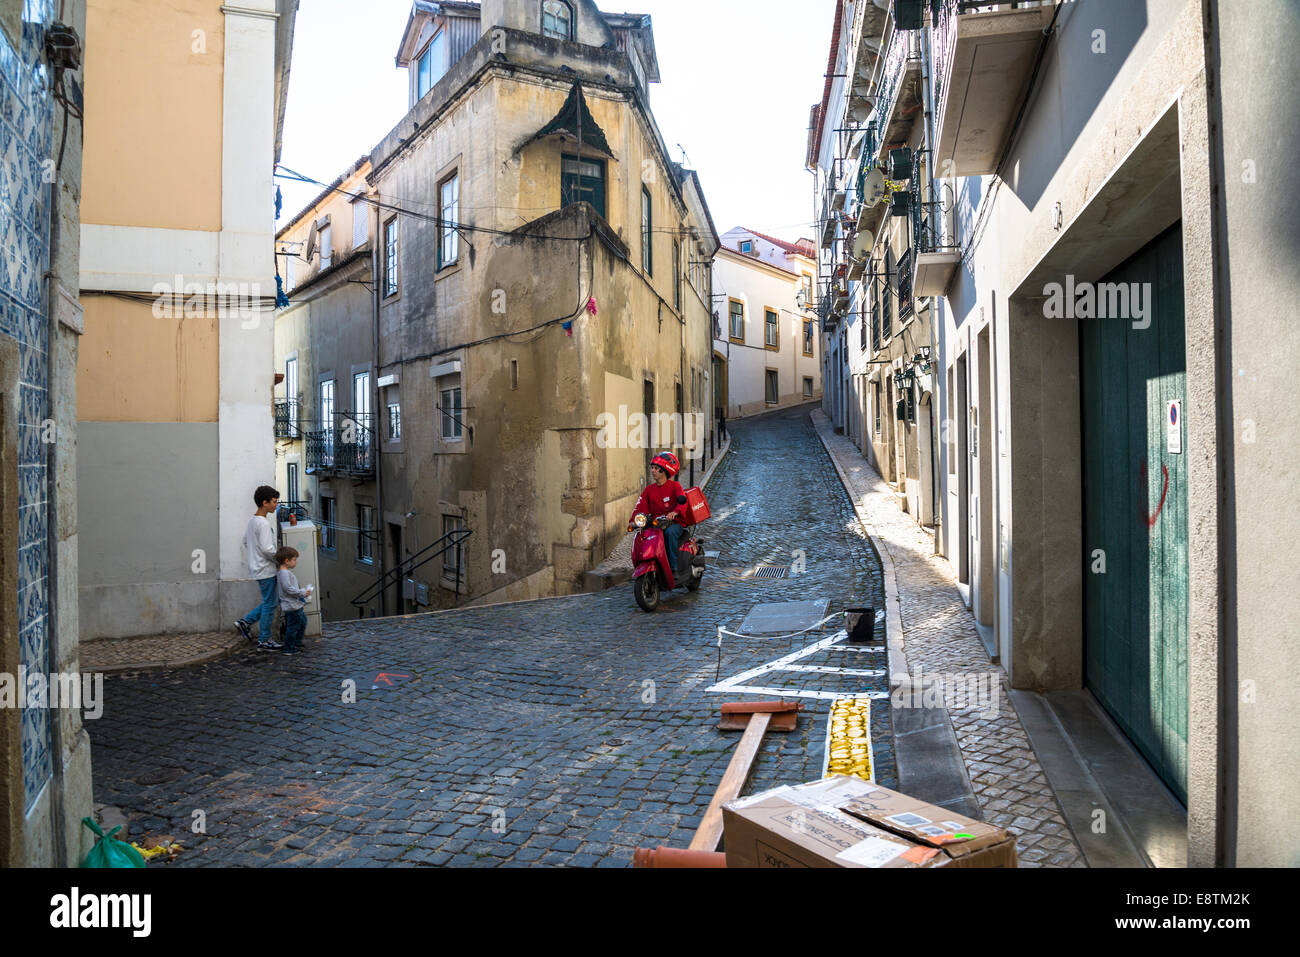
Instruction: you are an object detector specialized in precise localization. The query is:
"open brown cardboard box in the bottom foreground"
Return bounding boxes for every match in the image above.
[723,775,1017,867]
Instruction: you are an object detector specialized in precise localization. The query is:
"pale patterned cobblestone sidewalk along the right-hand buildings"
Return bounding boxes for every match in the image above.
[811,410,1087,867]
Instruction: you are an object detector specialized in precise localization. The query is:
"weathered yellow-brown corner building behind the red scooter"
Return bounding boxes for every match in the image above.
[276,0,718,618]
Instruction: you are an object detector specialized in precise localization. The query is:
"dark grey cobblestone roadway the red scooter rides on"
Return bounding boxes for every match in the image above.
[87,406,896,867]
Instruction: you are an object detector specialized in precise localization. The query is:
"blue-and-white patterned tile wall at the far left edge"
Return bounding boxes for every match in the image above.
[0,0,59,809]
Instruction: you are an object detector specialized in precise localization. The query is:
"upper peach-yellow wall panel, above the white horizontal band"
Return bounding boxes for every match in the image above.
[81,0,225,230]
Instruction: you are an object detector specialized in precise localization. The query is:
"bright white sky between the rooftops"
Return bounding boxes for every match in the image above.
[277,0,835,239]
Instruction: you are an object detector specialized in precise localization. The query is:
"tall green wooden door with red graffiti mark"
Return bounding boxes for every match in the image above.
[1079,226,1197,802]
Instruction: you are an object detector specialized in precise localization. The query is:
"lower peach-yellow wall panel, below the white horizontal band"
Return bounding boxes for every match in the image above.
[77,295,217,423]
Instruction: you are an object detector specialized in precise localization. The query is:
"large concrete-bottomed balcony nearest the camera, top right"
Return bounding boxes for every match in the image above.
[933,0,1053,176]
